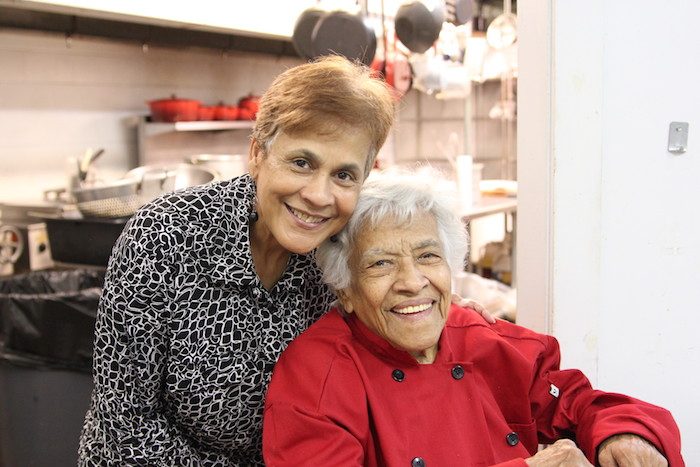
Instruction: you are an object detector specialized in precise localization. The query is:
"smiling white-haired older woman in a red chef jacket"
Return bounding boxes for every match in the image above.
[263,169,684,467]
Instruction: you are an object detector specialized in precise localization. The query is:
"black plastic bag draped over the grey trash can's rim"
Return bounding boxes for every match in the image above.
[0,269,105,373]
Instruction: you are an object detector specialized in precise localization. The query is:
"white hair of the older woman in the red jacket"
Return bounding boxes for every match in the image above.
[316,167,469,290]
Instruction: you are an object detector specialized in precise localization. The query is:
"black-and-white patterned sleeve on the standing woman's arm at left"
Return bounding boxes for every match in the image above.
[80,215,212,466]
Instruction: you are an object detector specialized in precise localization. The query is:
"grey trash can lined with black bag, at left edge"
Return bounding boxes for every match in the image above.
[0,268,105,467]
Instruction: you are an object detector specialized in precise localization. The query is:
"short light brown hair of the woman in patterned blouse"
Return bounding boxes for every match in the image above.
[253,55,395,175]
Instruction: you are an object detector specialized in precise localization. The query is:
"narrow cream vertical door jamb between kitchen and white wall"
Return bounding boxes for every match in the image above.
[516,2,553,332]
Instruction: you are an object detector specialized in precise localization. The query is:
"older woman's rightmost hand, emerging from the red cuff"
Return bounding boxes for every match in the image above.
[598,434,668,467]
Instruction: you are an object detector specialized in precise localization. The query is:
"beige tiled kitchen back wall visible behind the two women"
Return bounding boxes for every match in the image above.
[0,29,515,202]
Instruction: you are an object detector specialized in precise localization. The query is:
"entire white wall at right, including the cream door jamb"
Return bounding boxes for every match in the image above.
[518,0,700,465]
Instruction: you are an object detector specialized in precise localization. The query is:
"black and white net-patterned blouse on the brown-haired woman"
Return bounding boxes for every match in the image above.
[79,175,334,466]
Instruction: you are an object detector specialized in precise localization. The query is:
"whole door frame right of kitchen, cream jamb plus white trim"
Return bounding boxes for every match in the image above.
[516,0,605,383]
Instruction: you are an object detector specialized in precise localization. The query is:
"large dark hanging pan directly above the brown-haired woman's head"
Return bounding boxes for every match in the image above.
[311,11,377,66]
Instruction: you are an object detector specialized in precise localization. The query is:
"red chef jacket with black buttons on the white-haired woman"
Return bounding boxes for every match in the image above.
[263,305,684,467]
